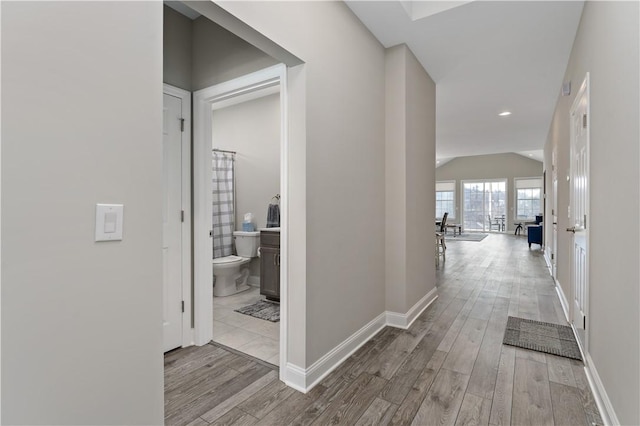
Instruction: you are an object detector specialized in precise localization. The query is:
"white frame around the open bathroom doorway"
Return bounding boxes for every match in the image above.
[193,64,289,377]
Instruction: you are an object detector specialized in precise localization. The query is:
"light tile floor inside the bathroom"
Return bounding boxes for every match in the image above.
[213,287,280,365]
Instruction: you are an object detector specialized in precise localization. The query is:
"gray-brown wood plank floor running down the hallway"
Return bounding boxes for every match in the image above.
[165,235,603,426]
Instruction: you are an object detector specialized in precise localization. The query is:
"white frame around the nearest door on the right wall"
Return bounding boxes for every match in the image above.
[569,72,591,352]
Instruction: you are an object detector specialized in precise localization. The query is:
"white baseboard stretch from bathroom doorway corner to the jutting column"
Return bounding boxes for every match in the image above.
[283,312,387,393]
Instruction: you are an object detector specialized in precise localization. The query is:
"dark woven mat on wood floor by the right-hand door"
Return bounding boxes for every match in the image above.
[502,317,582,361]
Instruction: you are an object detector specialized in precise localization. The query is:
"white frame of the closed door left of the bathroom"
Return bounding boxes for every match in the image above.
[162,83,194,347]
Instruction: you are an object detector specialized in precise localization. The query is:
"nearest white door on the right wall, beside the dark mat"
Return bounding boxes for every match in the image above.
[567,73,589,351]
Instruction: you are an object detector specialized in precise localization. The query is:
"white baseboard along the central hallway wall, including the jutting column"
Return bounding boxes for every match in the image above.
[282,288,438,393]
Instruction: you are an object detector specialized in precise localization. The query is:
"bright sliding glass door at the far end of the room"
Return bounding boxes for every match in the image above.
[462,180,507,232]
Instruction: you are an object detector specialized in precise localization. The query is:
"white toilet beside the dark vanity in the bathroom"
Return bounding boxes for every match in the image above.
[213,231,260,297]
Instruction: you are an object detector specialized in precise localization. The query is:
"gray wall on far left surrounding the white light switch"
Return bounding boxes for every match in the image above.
[0,2,164,424]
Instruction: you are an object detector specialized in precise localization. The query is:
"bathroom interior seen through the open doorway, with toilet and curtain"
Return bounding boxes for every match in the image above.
[211,85,281,365]
